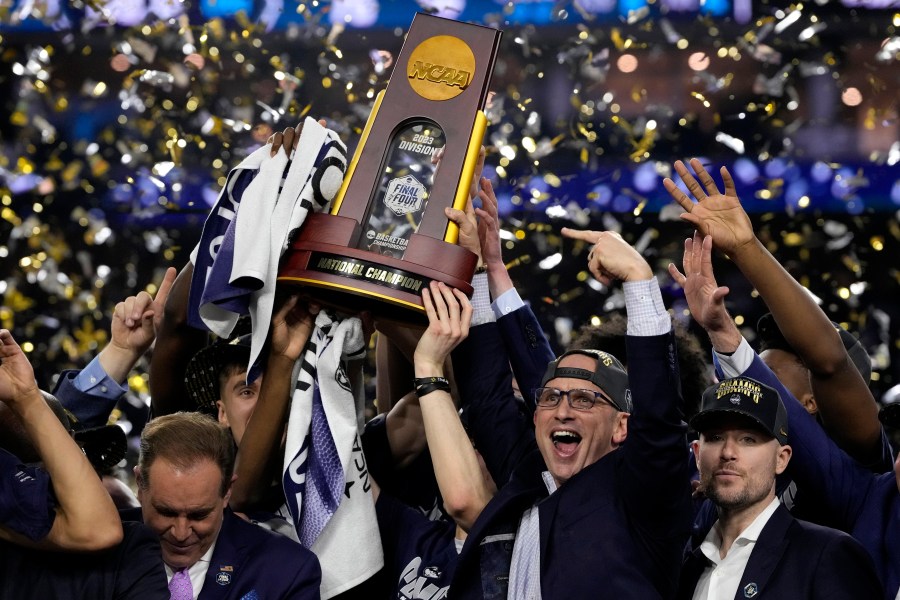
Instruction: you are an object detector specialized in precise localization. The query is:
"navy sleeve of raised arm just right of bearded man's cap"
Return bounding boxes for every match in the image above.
[743,356,875,531]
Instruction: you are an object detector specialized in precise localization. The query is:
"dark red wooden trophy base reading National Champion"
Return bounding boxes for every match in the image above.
[278,213,478,322]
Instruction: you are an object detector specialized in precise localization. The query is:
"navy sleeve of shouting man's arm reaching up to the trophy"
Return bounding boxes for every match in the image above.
[453,323,546,487]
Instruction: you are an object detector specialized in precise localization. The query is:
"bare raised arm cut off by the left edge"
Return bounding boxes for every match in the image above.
[0,329,122,551]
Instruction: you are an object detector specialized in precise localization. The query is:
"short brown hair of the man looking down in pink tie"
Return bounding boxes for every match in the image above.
[138,412,234,497]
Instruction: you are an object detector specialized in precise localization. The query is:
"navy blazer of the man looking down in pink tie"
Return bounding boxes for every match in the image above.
[122,508,322,600]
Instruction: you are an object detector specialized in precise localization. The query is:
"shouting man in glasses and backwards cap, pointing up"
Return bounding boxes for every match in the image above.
[442,224,691,600]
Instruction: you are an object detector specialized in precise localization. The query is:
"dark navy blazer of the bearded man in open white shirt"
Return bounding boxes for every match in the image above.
[678,504,884,600]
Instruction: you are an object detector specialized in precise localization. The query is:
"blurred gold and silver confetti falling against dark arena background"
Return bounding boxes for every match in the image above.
[0,0,900,404]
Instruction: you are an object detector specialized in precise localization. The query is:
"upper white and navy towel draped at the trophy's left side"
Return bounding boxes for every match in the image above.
[190,117,347,381]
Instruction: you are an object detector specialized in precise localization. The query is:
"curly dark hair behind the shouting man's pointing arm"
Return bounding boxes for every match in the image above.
[567,313,713,419]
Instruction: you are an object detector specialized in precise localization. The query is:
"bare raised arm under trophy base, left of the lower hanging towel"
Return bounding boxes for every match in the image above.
[231,296,319,511]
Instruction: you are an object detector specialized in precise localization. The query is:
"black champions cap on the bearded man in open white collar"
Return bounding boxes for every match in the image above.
[691,377,788,446]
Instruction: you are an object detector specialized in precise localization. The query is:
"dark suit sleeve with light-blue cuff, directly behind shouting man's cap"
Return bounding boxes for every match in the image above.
[497,304,556,412]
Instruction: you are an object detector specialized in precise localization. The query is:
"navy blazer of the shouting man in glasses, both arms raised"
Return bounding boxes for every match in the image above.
[449,309,692,600]
